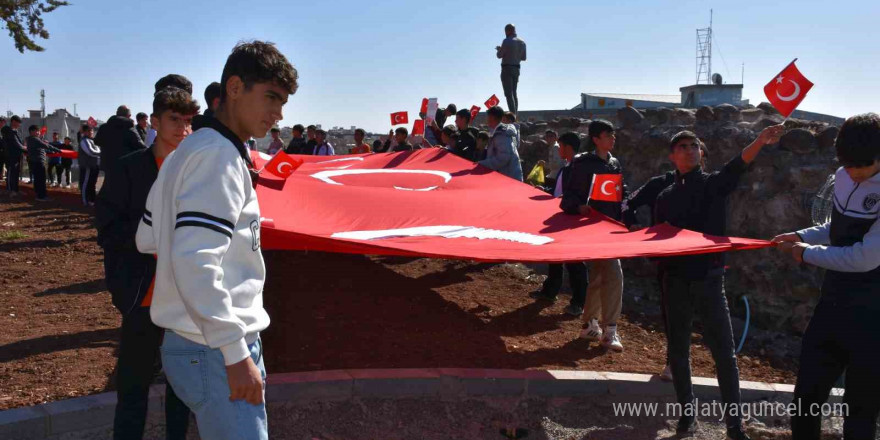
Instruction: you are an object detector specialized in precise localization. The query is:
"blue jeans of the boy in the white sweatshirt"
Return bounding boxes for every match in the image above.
[161,330,269,440]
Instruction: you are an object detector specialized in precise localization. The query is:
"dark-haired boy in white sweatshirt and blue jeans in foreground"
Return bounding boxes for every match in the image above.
[137,41,298,440]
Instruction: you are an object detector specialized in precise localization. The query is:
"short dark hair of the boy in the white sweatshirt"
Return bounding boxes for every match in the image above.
[220,41,299,103]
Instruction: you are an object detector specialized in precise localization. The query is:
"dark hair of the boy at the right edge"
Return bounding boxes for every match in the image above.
[834,113,880,168]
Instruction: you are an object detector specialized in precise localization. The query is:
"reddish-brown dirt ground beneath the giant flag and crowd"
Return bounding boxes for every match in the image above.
[0,180,796,409]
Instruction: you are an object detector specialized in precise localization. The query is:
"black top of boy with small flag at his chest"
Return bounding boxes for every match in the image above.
[559,152,629,221]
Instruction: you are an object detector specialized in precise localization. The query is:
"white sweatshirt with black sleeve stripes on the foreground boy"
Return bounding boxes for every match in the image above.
[137,119,269,365]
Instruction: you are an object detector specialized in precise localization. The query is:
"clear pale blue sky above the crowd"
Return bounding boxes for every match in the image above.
[0,0,880,132]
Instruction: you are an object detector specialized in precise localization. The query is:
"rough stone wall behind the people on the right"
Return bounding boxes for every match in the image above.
[520,104,839,333]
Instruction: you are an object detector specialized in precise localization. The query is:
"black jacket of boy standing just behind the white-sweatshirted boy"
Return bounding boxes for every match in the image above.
[95,148,159,314]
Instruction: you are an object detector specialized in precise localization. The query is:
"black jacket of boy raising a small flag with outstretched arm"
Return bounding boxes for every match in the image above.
[654,155,748,279]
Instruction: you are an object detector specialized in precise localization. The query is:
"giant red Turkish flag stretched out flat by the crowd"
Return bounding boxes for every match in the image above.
[249,148,770,262]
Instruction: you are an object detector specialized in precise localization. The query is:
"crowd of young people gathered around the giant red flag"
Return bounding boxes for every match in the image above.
[0,31,880,440]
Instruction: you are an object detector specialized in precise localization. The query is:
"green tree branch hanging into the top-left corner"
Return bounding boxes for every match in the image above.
[0,0,68,53]
